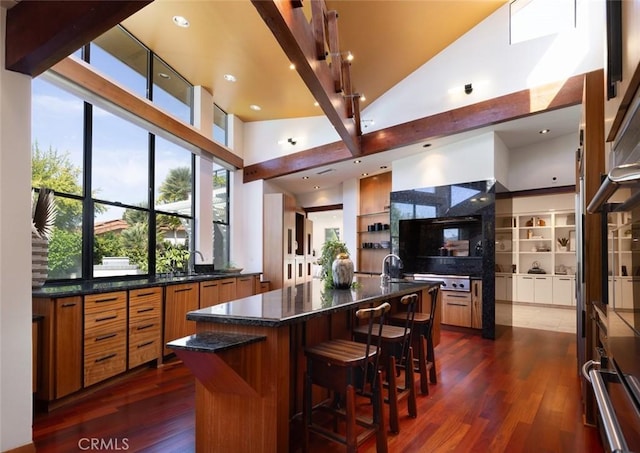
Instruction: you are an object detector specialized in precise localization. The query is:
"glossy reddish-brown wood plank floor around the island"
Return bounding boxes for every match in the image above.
[33,328,602,453]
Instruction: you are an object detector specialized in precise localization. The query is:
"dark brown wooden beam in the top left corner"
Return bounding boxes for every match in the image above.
[5,0,152,77]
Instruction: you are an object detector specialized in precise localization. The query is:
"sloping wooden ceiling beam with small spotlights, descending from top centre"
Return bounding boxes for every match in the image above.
[251,0,360,156]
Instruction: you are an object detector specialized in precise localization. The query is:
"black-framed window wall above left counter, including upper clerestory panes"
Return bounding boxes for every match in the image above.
[32,27,204,280]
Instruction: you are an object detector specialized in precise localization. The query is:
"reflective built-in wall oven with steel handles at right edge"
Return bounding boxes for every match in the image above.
[583,163,640,452]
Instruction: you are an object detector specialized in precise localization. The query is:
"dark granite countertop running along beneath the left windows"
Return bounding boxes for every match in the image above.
[31,272,261,297]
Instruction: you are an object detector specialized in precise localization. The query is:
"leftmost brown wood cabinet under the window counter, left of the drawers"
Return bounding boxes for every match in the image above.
[33,296,82,401]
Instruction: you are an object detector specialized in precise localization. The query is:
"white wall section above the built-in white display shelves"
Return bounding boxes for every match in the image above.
[506,133,579,191]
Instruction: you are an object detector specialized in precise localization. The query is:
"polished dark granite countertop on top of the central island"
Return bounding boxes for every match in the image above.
[187,276,441,327]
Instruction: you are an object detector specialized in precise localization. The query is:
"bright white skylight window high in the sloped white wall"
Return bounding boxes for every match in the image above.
[509,0,576,44]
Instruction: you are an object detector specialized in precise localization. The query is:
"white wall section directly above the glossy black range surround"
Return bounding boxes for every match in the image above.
[392,132,495,191]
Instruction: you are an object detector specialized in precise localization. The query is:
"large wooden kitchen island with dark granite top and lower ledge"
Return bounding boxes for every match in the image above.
[168,277,440,453]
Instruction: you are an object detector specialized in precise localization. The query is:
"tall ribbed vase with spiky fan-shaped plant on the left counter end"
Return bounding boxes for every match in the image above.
[31,187,57,288]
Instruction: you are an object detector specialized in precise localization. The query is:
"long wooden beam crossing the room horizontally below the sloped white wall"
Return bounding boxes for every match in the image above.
[244,74,585,182]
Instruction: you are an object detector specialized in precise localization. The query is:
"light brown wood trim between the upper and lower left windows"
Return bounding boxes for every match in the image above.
[51,57,244,168]
